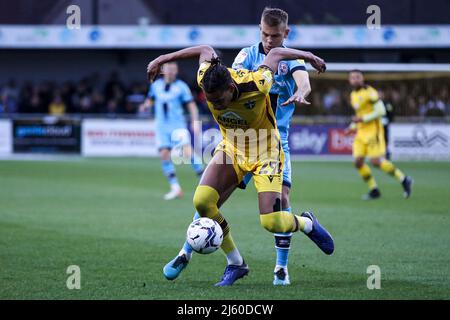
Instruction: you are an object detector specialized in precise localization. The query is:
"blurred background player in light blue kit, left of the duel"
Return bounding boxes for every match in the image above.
[142,62,203,200]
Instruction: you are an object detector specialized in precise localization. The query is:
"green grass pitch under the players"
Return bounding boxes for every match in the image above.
[0,158,450,300]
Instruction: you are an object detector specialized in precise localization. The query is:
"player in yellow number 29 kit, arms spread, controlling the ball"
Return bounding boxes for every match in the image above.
[147,46,334,286]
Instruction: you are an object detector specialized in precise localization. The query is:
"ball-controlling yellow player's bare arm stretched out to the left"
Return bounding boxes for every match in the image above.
[147,45,217,82]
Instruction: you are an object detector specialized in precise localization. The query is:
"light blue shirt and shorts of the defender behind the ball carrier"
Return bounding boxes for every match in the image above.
[233,42,306,188]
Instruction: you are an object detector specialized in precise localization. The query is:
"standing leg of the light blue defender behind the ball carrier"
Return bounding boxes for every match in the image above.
[273,141,292,285]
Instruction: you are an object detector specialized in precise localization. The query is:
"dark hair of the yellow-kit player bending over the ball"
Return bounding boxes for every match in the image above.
[202,56,232,93]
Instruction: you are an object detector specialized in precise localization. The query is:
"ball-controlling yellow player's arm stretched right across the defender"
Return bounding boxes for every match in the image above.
[262,48,326,73]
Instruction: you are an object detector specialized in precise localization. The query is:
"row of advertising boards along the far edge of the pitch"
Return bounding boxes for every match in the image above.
[0,117,450,160]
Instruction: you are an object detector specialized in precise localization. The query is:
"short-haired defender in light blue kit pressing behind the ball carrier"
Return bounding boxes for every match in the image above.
[163,8,326,285]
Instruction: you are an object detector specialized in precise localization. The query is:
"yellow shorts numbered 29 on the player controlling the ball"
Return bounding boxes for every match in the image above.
[214,140,284,193]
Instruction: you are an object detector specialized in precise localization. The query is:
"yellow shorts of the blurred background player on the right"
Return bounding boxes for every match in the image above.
[353,131,386,158]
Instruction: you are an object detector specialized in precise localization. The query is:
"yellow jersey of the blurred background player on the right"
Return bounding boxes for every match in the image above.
[350,85,383,135]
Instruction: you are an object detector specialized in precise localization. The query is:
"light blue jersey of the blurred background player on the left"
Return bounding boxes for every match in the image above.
[148,78,193,148]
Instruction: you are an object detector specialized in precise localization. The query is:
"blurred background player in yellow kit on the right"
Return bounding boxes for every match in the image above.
[347,70,413,200]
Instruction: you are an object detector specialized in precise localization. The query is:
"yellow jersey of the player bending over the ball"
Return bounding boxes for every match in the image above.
[197,62,280,158]
